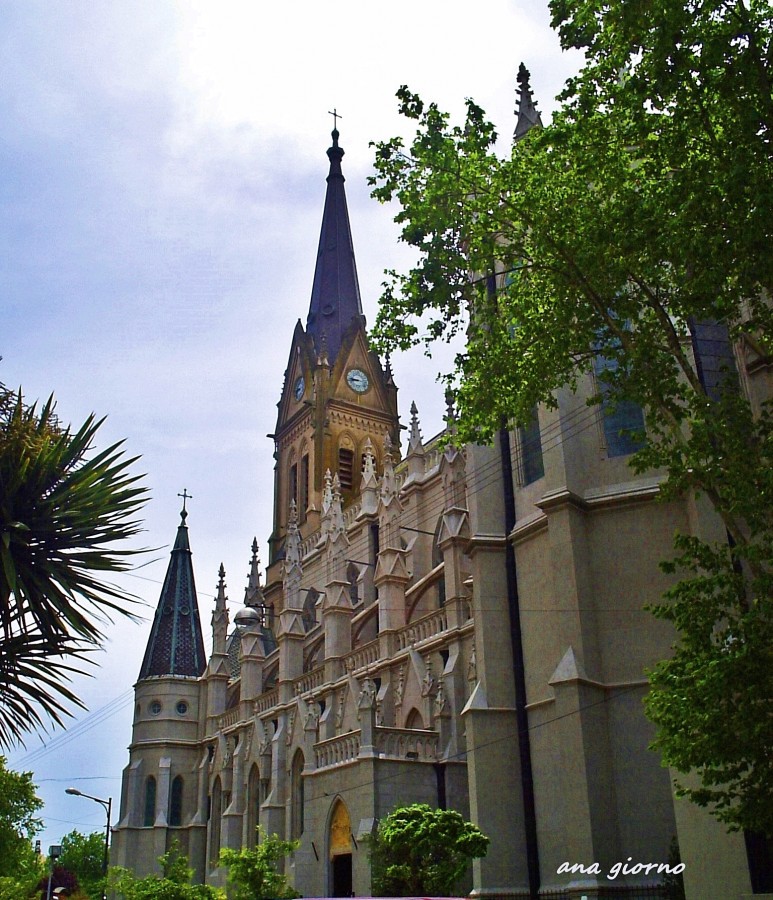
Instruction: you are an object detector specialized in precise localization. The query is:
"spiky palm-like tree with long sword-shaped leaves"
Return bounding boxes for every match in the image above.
[0,385,146,747]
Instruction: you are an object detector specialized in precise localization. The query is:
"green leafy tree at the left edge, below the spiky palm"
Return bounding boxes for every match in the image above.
[0,756,43,876]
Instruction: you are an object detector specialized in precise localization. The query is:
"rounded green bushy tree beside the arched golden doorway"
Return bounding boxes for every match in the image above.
[370,803,489,897]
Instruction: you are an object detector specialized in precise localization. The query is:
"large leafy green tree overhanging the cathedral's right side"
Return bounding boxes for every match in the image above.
[372,0,773,834]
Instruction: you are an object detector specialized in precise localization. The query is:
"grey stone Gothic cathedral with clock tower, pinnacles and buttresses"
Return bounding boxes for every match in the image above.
[111,75,768,900]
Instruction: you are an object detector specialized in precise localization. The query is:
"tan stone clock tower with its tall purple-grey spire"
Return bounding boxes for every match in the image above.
[270,129,399,566]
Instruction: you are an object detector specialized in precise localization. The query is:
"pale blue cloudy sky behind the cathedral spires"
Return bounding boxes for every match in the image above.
[0,0,580,851]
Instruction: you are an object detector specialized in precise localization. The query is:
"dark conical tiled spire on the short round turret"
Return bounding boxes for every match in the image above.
[140,502,206,680]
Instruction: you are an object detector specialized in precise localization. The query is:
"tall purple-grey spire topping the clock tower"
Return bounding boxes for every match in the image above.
[306,129,364,365]
